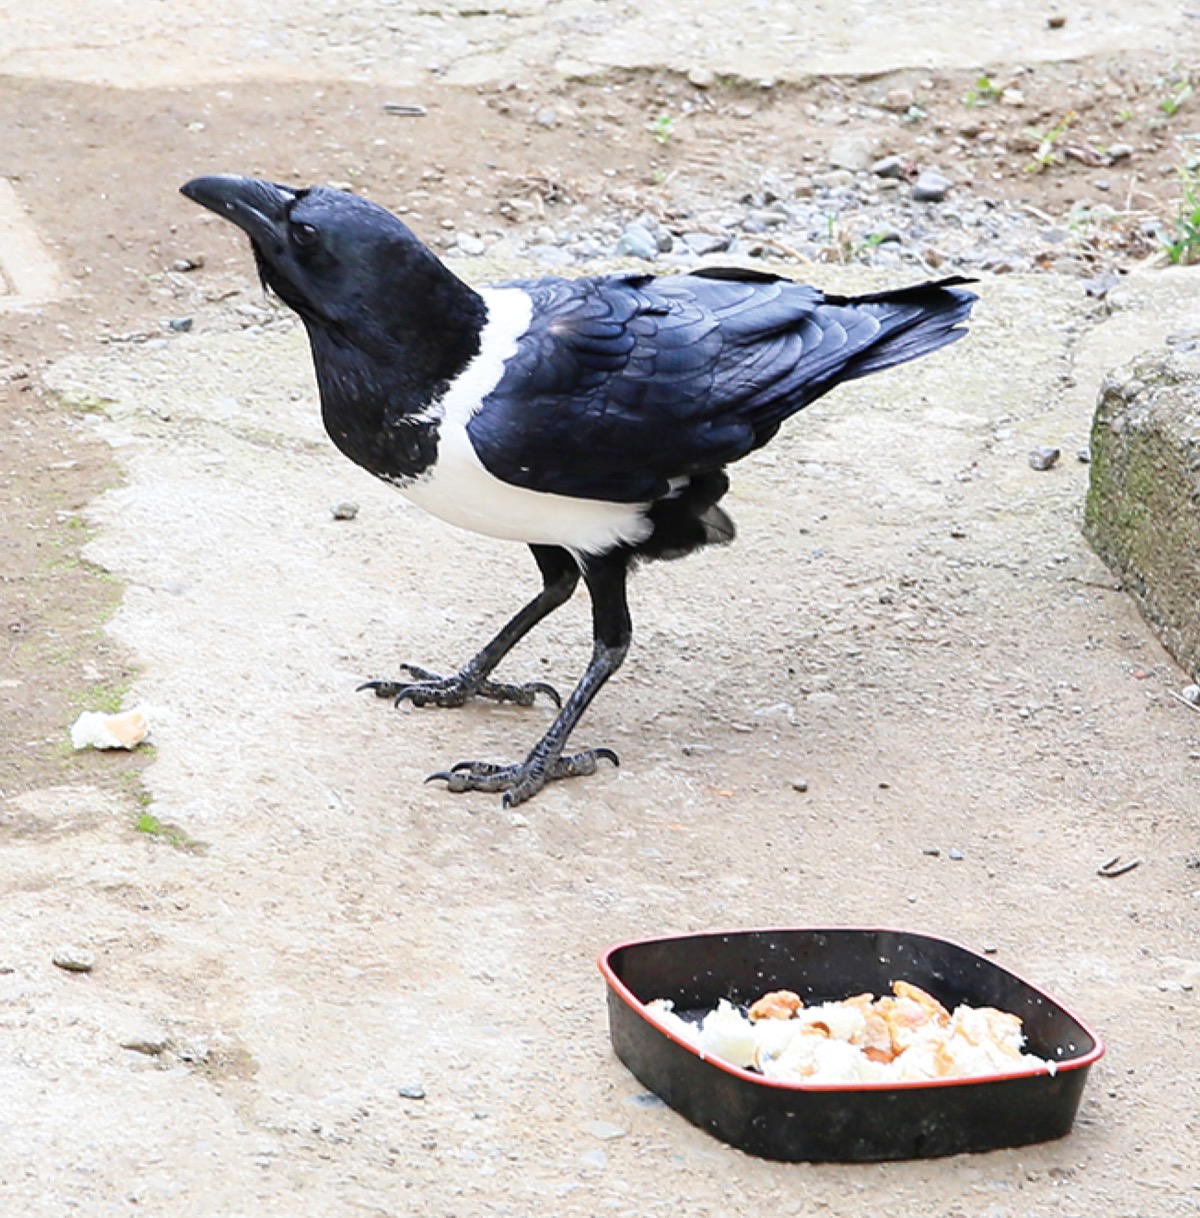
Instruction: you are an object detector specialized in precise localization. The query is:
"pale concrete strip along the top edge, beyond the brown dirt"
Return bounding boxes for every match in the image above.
[0,0,1179,90]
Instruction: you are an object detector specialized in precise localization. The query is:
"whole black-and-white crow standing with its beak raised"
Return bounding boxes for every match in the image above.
[183,174,976,805]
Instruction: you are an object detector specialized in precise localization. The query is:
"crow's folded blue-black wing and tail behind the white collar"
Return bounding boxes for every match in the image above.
[468,268,975,503]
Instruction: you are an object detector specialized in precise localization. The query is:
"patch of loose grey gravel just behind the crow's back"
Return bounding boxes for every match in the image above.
[447,154,1101,280]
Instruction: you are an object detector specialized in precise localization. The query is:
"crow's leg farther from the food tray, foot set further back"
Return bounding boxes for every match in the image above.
[358,546,579,706]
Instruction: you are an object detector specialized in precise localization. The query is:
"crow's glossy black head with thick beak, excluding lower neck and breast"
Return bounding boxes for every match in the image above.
[182,174,481,358]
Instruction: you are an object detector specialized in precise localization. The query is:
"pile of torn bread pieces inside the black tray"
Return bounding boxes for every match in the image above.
[646,980,1056,1084]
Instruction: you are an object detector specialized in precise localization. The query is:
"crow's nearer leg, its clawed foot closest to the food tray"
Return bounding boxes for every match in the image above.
[430,552,634,808]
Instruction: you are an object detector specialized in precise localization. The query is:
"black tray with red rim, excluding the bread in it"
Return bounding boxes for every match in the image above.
[599,928,1104,1162]
